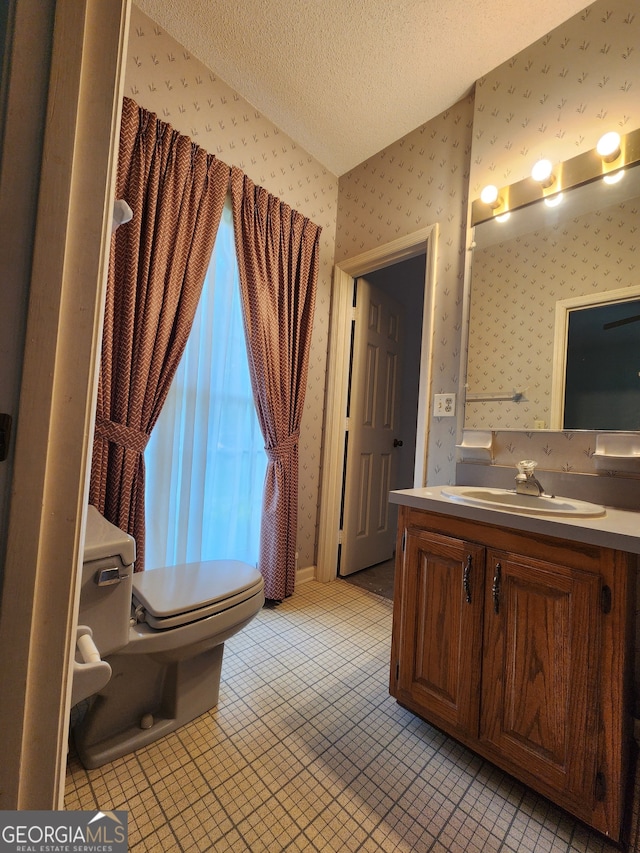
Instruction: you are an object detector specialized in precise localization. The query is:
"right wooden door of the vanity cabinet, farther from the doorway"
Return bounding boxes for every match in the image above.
[480,550,601,806]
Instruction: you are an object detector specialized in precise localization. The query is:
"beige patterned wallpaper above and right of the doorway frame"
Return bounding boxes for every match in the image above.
[336,98,473,485]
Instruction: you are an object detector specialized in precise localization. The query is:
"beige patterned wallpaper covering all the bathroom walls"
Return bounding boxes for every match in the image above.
[125,0,640,567]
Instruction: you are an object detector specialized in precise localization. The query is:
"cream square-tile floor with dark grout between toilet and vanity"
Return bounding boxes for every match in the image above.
[66,581,638,853]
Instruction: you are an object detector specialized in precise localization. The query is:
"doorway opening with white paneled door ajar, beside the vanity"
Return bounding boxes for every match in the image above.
[337,254,426,577]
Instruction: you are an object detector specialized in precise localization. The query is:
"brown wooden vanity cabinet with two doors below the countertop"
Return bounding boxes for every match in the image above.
[390,506,637,841]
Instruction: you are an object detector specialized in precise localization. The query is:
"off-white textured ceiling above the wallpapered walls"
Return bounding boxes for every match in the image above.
[135,0,585,175]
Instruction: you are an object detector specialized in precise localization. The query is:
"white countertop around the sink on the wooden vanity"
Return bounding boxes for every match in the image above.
[389,486,640,554]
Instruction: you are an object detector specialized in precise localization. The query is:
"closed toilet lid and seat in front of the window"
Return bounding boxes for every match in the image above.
[133,560,263,628]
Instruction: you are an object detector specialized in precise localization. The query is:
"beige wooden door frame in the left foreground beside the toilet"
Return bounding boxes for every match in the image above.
[0,0,131,811]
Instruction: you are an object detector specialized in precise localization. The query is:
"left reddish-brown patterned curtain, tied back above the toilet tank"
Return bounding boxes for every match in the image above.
[89,98,229,571]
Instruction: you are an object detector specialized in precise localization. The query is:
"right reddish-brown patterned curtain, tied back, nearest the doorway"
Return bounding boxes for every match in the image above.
[231,167,321,601]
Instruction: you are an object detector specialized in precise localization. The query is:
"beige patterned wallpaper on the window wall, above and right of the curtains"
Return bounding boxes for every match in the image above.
[125,6,338,567]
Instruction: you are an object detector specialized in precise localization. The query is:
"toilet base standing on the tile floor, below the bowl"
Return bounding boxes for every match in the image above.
[74,643,224,770]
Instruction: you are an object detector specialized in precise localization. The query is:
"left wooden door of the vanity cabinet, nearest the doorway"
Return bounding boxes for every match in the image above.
[396,527,484,737]
